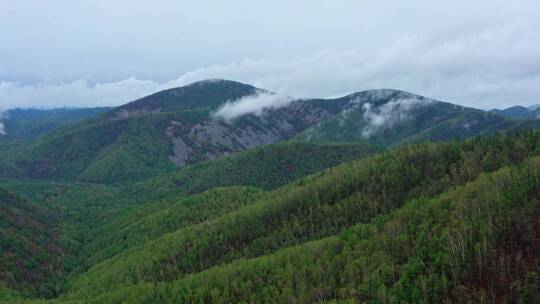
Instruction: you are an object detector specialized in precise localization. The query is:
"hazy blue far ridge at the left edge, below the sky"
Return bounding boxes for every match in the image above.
[0,107,110,144]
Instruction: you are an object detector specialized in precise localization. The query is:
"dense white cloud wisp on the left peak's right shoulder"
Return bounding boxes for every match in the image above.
[213,92,293,121]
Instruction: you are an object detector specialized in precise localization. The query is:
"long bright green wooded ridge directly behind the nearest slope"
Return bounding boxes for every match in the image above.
[64,132,540,297]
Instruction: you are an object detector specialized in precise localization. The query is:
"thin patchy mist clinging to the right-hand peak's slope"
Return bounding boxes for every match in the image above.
[362,98,432,137]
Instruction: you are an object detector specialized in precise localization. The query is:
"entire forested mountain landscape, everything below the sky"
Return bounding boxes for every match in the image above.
[0,79,540,303]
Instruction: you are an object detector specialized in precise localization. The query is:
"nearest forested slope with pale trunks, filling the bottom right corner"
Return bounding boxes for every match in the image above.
[84,158,540,303]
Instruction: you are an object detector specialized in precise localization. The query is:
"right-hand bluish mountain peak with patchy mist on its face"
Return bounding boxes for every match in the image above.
[297,90,519,147]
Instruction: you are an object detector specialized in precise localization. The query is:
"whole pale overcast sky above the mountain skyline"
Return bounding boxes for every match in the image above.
[0,0,540,110]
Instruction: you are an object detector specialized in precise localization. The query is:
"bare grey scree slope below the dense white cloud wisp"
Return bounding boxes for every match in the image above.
[166,101,332,167]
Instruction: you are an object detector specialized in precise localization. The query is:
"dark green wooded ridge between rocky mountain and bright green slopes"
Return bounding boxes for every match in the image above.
[133,141,376,195]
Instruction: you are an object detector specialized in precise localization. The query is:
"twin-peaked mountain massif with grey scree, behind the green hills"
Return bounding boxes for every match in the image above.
[0,80,530,183]
